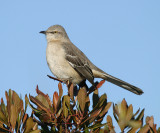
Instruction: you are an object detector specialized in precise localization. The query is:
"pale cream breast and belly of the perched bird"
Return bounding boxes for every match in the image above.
[46,43,83,84]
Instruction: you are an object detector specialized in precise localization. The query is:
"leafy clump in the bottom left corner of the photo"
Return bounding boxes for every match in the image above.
[0,90,40,133]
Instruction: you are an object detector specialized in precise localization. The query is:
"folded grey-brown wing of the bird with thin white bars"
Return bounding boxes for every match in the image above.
[62,43,94,84]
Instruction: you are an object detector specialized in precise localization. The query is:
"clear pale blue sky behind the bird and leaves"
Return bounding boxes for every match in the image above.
[0,0,160,130]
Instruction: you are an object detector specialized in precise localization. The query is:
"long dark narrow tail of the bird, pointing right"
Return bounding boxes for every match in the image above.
[92,70,143,95]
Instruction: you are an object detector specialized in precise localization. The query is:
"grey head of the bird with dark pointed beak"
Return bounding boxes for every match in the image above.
[40,25,69,42]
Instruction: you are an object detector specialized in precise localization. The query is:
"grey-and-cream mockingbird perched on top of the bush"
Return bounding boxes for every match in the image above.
[40,25,143,95]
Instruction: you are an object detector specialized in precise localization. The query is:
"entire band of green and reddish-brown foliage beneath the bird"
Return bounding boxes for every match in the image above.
[0,81,160,133]
